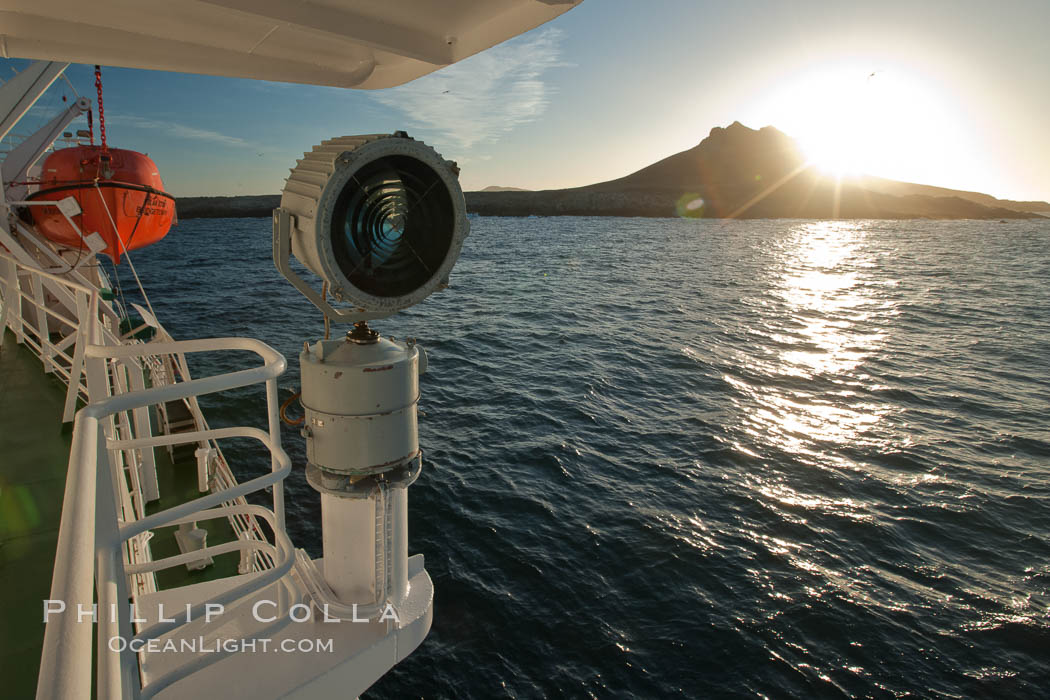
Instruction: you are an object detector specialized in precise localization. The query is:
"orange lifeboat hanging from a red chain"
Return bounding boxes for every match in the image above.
[28,146,175,263]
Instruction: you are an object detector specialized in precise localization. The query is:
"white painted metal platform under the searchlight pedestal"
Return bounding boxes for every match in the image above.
[137,550,434,700]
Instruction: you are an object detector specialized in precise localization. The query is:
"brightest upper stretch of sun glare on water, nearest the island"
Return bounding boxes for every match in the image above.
[725,221,891,457]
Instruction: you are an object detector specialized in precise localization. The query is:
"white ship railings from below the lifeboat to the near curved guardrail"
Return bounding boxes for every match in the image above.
[0,251,294,698]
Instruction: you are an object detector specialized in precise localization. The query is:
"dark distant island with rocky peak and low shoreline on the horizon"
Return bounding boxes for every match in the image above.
[176,122,1050,219]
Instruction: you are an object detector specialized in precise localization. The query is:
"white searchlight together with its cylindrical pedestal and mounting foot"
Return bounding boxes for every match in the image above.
[273,131,469,633]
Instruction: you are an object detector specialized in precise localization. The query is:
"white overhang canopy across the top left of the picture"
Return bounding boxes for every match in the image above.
[0,0,582,88]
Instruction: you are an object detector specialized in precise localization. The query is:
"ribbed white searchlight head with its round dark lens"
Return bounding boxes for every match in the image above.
[274,131,469,321]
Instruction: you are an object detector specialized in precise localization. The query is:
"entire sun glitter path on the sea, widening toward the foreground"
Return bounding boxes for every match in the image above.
[663,221,1045,678]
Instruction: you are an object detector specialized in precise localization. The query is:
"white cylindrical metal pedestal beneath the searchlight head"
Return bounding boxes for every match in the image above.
[299,334,422,606]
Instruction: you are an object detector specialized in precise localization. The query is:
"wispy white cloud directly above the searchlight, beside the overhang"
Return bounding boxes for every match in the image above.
[373,27,566,149]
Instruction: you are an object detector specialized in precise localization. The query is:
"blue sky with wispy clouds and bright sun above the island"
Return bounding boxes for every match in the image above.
[0,0,1050,200]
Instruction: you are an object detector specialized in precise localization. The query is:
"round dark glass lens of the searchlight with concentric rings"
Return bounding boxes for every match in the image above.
[331,155,457,297]
